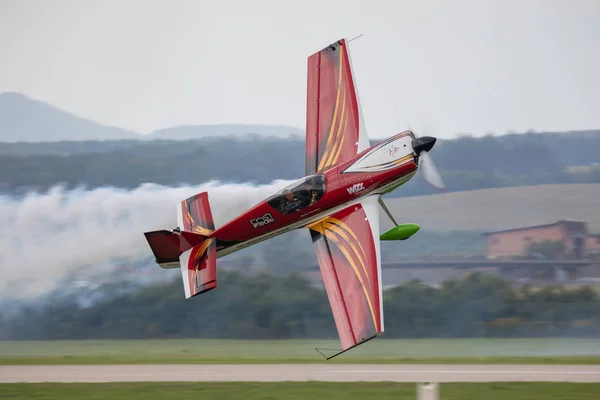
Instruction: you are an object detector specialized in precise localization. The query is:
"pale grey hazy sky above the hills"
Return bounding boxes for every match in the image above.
[0,0,600,137]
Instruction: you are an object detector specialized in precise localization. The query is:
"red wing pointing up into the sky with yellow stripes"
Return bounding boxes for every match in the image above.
[306,39,370,175]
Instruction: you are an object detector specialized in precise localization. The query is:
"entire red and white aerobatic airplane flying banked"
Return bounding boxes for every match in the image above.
[145,39,443,358]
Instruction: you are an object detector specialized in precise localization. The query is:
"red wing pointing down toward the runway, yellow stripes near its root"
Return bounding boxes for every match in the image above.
[308,195,383,358]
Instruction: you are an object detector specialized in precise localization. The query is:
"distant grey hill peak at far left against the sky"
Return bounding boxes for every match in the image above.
[0,93,141,142]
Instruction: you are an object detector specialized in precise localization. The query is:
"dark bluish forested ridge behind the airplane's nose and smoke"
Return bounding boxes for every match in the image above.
[0,131,600,196]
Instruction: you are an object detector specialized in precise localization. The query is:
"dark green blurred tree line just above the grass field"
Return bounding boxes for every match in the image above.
[0,271,600,339]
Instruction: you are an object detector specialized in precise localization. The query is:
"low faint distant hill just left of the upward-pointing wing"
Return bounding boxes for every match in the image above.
[147,124,304,140]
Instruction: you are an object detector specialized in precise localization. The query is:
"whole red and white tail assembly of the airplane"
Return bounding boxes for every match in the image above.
[145,192,217,299]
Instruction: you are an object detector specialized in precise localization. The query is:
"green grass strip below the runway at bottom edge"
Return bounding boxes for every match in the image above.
[0,382,600,400]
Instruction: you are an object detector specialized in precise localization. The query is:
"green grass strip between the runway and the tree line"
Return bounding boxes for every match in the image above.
[0,339,600,365]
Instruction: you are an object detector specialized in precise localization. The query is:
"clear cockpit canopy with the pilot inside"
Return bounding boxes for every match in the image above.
[267,174,325,214]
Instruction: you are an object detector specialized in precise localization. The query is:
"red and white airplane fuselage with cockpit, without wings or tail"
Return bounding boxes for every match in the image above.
[211,131,418,258]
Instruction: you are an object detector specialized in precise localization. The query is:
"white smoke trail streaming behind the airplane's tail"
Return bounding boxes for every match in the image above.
[0,180,296,298]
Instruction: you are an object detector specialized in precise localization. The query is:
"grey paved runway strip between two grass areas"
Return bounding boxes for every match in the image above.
[0,364,600,383]
